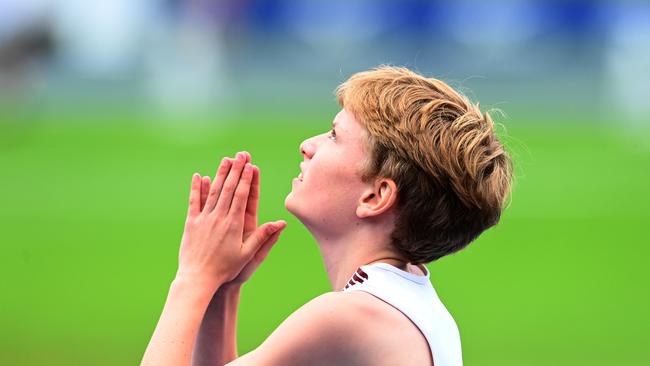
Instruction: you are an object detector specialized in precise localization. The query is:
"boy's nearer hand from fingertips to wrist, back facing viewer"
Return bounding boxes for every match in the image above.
[177,154,286,290]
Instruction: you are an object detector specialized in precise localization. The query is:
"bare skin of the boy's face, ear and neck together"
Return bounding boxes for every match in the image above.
[285,110,407,290]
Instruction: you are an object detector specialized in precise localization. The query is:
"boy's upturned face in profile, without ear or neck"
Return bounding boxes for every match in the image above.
[285,109,370,235]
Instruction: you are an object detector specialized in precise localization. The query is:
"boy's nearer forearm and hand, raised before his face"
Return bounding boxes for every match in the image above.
[141,154,286,365]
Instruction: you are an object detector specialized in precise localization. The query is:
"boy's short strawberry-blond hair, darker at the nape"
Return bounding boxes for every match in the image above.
[336,66,512,264]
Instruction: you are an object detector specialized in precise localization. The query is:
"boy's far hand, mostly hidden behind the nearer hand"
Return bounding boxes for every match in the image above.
[196,152,282,286]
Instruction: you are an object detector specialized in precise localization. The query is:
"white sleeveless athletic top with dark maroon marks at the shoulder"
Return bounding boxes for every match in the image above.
[343,263,463,366]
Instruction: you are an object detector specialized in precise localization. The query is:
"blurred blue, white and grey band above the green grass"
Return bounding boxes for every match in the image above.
[0,0,650,123]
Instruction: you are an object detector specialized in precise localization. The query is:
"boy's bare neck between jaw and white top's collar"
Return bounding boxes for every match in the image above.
[312,226,407,291]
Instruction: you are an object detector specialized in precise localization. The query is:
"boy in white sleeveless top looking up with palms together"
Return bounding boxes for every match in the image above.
[142,67,512,366]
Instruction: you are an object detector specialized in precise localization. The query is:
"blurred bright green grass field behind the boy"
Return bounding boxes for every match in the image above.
[0,107,650,366]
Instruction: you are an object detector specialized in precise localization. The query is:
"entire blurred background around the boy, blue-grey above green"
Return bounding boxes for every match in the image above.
[0,0,650,366]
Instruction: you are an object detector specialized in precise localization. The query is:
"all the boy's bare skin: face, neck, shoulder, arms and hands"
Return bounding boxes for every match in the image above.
[142,110,432,366]
